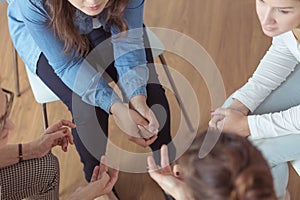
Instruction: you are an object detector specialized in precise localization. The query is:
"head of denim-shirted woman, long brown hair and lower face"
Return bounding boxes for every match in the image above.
[45,0,129,56]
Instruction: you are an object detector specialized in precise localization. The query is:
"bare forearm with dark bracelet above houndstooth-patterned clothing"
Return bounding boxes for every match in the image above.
[0,143,38,168]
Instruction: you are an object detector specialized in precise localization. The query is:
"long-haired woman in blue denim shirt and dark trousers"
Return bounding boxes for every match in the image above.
[8,0,175,184]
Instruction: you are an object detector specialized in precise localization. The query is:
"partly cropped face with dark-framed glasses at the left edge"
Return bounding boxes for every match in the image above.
[0,88,14,148]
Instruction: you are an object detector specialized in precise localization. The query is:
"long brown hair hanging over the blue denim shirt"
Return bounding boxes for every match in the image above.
[47,0,129,56]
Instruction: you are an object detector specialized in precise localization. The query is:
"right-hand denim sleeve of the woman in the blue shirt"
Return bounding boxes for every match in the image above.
[111,0,149,101]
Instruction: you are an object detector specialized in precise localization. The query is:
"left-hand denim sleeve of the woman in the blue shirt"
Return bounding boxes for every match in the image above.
[18,0,120,112]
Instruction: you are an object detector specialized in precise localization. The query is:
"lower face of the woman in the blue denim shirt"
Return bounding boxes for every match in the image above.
[68,0,109,16]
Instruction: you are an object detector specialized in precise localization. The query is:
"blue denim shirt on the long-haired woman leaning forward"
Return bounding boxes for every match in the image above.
[7,0,148,112]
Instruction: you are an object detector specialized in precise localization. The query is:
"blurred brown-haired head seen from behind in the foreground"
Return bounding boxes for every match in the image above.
[179,133,276,200]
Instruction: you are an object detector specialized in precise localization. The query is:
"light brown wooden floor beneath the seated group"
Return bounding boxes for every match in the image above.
[0,0,300,200]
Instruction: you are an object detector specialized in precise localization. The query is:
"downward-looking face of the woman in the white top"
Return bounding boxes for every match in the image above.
[256,0,300,37]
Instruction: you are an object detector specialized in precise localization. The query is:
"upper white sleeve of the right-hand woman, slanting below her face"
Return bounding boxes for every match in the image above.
[233,36,298,112]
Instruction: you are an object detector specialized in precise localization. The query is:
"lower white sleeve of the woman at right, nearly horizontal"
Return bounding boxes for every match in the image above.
[248,106,300,139]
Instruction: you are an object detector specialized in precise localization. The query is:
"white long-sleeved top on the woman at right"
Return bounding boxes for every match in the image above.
[233,31,300,139]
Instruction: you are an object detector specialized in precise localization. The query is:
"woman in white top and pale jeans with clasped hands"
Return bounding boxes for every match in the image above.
[209,0,300,197]
